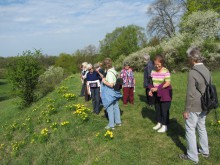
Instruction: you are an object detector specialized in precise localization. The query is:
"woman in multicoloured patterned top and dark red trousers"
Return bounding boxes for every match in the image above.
[120,62,135,106]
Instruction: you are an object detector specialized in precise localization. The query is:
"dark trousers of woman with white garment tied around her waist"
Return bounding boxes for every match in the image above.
[90,87,100,114]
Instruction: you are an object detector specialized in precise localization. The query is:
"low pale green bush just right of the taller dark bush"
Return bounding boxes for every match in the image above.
[37,66,64,95]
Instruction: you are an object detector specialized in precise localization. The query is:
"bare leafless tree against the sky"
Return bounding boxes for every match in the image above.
[147,0,183,38]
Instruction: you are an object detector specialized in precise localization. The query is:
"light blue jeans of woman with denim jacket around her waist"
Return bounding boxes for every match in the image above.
[107,101,121,127]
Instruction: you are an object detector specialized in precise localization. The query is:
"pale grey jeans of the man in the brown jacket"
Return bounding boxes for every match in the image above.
[185,112,209,162]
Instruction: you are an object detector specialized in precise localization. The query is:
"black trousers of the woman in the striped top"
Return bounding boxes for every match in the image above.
[154,97,171,125]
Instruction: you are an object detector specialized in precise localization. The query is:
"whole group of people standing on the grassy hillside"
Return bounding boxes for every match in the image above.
[81,47,211,163]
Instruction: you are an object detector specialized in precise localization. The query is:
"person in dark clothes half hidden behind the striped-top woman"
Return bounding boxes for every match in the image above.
[143,54,155,105]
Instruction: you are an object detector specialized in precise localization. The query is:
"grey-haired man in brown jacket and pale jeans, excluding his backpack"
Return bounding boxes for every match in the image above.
[179,47,211,164]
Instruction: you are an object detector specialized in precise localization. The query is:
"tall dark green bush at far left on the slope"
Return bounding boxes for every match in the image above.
[8,50,41,106]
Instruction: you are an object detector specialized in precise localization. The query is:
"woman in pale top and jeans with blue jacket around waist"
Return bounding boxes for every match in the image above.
[101,58,122,129]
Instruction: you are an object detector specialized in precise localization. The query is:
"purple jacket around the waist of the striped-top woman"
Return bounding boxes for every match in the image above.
[148,83,172,101]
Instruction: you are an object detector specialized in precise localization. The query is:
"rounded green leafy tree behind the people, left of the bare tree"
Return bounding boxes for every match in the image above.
[100,25,146,60]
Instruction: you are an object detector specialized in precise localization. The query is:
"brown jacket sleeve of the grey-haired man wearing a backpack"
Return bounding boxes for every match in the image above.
[185,71,196,112]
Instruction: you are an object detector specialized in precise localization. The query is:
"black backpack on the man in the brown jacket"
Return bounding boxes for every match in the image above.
[193,69,218,114]
